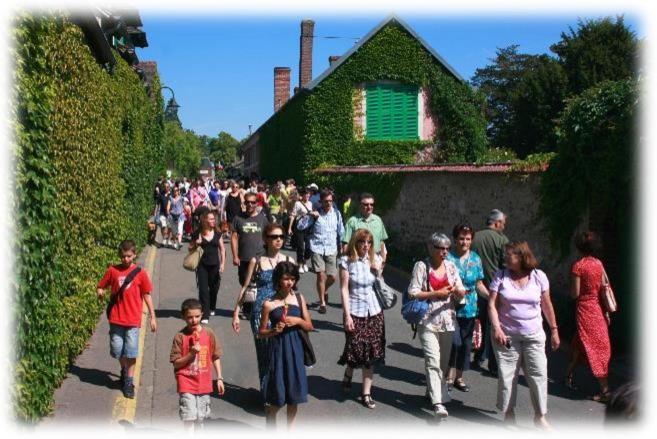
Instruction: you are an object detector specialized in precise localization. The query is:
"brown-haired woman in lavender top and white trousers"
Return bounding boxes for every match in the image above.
[488,241,560,429]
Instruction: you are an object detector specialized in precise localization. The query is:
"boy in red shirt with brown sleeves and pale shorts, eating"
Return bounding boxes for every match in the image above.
[169,299,224,431]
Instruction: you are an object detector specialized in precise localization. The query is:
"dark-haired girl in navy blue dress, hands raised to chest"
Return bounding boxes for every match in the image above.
[259,262,313,428]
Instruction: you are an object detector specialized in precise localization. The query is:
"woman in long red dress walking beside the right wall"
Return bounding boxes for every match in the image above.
[565,231,611,402]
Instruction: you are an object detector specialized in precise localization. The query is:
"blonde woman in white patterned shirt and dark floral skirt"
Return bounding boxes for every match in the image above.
[338,229,386,409]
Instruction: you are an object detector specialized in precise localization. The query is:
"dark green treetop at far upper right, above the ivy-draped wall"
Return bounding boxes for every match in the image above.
[550,17,639,94]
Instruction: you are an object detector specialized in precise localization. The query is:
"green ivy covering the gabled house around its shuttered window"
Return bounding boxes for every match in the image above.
[259,22,486,184]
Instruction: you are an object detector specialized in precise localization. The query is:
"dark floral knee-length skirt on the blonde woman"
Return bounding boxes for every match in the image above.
[338,312,386,368]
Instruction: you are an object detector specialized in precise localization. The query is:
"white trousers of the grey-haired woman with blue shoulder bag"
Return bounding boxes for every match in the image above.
[417,325,454,405]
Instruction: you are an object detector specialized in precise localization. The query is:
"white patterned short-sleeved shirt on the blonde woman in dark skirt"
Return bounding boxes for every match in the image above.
[339,255,381,317]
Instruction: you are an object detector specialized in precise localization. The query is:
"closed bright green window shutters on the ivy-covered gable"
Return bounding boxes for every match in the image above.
[365,84,419,140]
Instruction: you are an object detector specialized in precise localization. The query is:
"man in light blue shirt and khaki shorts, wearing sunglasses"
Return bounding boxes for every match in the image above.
[309,189,344,314]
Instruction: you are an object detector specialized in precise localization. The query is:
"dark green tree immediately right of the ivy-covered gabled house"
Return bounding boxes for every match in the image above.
[472,45,567,158]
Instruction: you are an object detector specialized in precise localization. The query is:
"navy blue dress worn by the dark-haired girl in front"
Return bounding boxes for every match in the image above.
[262,305,308,407]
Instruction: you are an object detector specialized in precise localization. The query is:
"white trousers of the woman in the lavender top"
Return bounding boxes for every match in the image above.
[493,328,547,415]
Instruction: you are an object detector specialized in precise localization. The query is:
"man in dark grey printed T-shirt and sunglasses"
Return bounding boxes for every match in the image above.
[230,192,269,315]
